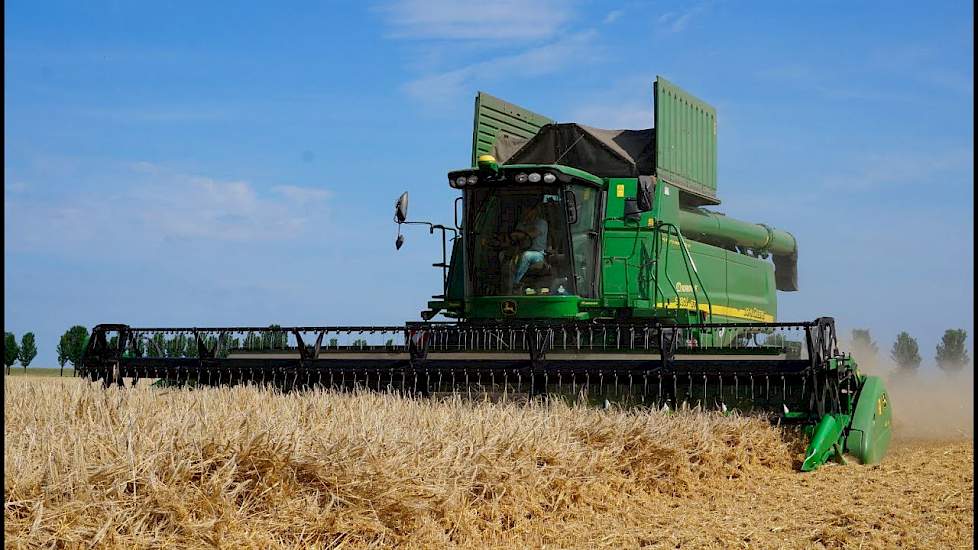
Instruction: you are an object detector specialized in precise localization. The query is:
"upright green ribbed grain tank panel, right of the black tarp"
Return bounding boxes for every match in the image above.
[653,76,720,204]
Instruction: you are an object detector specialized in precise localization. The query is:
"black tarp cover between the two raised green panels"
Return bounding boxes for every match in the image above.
[492,123,655,178]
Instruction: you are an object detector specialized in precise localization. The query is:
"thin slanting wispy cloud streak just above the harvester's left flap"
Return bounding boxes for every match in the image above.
[404,31,599,103]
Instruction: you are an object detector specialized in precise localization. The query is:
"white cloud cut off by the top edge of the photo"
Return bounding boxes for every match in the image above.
[378,0,572,40]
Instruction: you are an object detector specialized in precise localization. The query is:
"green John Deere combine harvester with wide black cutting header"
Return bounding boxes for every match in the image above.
[78,77,891,470]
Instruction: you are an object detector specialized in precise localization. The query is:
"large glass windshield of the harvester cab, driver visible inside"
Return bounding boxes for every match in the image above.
[465,185,597,296]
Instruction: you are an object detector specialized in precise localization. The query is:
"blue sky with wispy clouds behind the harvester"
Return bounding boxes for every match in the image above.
[4,0,974,368]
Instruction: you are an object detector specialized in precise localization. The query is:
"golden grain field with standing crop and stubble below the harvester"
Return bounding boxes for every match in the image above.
[4,378,974,548]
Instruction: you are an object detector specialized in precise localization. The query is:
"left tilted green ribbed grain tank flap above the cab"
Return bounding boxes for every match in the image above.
[472,92,554,166]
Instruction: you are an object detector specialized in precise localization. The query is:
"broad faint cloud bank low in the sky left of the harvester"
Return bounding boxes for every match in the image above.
[4,162,329,251]
